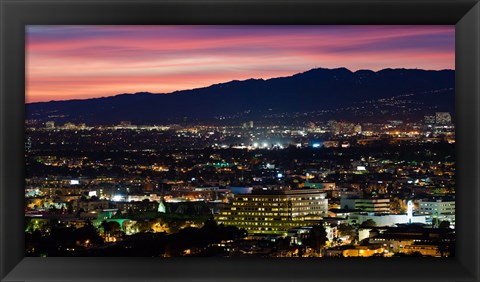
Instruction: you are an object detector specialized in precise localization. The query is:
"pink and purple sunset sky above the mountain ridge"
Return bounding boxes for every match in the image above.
[26,26,455,103]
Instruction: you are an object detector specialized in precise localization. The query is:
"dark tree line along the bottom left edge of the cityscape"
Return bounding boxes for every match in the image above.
[26,220,247,257]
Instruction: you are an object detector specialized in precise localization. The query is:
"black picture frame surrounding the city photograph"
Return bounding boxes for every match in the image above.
[0,0,480,281]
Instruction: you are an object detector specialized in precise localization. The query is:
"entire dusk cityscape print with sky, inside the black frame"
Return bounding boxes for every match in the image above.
[25,26,456,259]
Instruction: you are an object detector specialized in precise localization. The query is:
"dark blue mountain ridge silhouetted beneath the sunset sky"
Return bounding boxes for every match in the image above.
[26,68,455,124]
